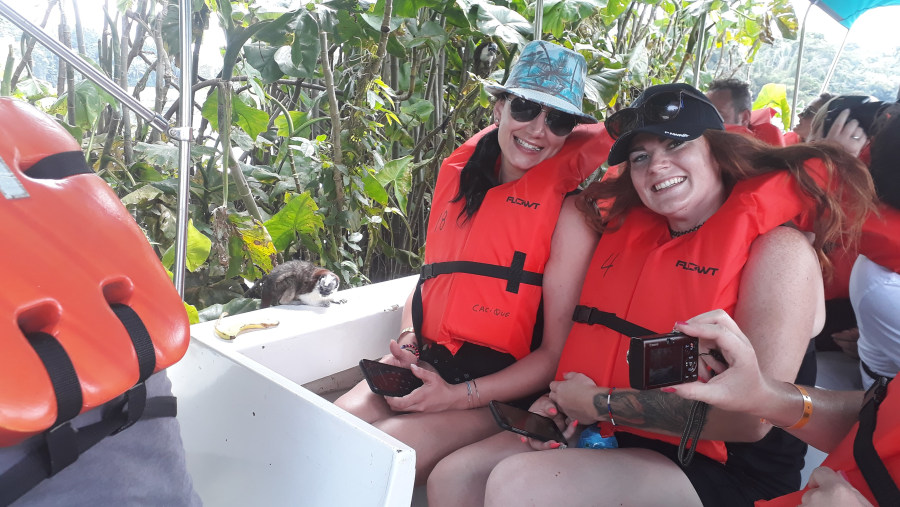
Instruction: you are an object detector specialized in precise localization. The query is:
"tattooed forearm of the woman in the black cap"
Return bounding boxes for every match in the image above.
[594,390,691,435]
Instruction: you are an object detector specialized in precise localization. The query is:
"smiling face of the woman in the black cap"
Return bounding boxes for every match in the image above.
[628,134,726,231]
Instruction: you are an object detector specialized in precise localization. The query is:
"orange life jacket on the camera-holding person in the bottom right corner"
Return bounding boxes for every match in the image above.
[756,382,900,507]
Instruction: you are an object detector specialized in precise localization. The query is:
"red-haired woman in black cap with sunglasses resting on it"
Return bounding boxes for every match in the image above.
[428,84,873,507]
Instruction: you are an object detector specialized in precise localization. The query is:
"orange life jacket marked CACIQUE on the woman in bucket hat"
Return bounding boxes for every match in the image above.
[422,123,612,359]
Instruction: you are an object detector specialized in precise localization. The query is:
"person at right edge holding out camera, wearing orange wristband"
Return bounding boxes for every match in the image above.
[661,310,900,507]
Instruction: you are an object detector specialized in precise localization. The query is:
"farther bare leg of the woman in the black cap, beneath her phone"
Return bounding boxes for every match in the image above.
[428,431,532,507]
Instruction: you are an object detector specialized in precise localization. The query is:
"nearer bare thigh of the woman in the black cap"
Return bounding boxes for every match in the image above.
[484,449,702,507]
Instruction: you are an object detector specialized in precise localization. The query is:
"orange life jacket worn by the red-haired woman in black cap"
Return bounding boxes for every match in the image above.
[556,171,811,462]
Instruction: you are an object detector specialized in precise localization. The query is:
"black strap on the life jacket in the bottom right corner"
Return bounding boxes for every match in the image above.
[853,377,900,505]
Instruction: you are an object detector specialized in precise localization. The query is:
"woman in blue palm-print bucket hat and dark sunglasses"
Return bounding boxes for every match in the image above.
[336,41,612,480]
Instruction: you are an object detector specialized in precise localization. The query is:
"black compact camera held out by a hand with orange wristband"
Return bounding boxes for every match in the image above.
[628,333,700,389]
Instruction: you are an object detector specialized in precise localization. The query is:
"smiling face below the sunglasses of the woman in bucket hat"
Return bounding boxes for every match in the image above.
[494,99,567,183]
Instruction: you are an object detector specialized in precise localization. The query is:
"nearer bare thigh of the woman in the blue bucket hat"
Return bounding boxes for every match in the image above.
[375,407,500,484]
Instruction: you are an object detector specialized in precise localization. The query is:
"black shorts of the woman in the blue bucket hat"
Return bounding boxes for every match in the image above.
[419,342,543,409]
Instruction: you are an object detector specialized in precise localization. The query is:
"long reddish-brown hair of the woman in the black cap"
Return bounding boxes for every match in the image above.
[576,130,876,273]
